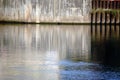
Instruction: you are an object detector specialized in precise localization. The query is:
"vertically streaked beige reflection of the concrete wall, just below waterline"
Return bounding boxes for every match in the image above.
[0,25,90,59]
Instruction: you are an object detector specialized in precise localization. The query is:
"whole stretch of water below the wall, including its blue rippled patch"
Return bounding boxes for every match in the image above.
[0,24,120,80]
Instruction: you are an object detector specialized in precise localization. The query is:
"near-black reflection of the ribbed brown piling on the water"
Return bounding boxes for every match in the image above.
[91,25,120,66]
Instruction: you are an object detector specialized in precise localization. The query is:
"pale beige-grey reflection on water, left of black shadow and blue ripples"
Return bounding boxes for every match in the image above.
[0,25,90,80]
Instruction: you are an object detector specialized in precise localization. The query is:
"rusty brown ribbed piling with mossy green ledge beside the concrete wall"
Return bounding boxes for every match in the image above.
[92,0,120,25]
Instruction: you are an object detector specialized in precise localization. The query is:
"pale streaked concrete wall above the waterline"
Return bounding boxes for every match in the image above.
[0,0,91,22]
